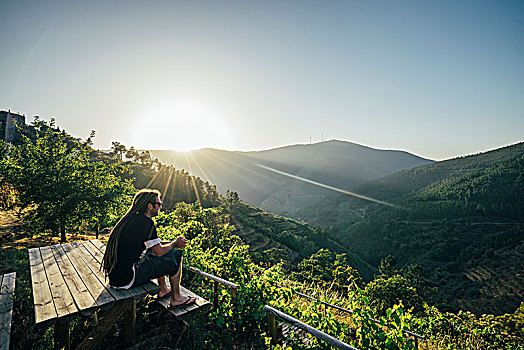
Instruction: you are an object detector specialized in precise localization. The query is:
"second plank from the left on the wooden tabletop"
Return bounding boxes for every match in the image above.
[40,247,79,318]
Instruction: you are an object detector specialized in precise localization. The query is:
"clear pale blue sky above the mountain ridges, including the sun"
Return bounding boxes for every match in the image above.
[0,0,524,160]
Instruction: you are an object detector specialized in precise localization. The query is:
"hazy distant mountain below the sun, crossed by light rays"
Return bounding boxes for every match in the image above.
[151,140,431,218]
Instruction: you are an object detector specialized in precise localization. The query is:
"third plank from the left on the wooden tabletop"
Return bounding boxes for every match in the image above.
[51,245,98,316]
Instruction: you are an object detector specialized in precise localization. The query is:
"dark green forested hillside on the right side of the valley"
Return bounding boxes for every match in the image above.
[296,143,524,313]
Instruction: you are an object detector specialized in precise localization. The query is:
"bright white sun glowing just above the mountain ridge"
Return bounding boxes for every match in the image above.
[132,102,232,151]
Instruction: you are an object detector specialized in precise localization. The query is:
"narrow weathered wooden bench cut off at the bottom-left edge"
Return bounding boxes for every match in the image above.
[0,272,16,350]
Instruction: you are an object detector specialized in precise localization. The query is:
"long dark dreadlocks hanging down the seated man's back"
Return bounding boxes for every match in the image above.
[101,188,160,277]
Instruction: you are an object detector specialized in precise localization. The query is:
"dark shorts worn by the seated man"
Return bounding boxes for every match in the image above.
[133,249,182,287]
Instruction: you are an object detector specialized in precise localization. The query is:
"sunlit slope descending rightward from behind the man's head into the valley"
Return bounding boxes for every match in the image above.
[107,143,378,281]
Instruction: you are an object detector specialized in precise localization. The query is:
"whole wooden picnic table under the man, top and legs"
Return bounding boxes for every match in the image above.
[29,240,160,349]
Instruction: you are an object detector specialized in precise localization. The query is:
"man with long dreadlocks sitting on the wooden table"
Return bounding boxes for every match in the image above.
[102,189,195,307]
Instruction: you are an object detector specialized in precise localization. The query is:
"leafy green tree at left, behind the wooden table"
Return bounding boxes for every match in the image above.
[2,121,133,241]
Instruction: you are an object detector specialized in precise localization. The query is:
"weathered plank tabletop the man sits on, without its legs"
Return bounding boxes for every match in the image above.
[29,240,160,327]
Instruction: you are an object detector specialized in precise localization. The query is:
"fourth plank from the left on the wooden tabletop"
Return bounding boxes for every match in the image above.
[61,244,116,306]
